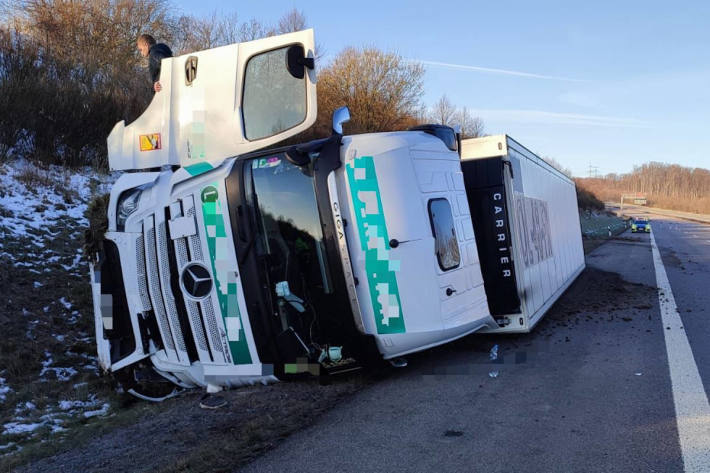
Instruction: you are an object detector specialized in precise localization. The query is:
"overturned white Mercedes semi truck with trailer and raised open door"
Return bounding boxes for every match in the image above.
[91,30,584,399]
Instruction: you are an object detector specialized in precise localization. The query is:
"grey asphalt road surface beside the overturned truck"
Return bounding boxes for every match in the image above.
[244,212,710,472]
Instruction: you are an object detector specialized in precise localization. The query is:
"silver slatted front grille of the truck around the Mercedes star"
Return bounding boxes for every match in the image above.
[136,196,229,365]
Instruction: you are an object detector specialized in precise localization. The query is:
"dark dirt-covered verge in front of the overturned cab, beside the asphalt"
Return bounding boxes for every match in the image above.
[16,374,370,472]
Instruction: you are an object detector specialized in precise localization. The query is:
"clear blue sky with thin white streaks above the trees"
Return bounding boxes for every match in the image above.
[176,0,710,176]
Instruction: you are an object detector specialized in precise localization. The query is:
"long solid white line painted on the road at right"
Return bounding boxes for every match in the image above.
[651,233,710,473]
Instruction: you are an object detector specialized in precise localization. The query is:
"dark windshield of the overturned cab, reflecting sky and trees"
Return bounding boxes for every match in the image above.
[245,155,332,308]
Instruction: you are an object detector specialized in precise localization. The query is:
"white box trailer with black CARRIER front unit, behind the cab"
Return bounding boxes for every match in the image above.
[461,135,584,332]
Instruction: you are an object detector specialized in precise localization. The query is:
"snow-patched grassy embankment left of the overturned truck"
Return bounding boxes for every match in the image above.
[0,162,120,471]
